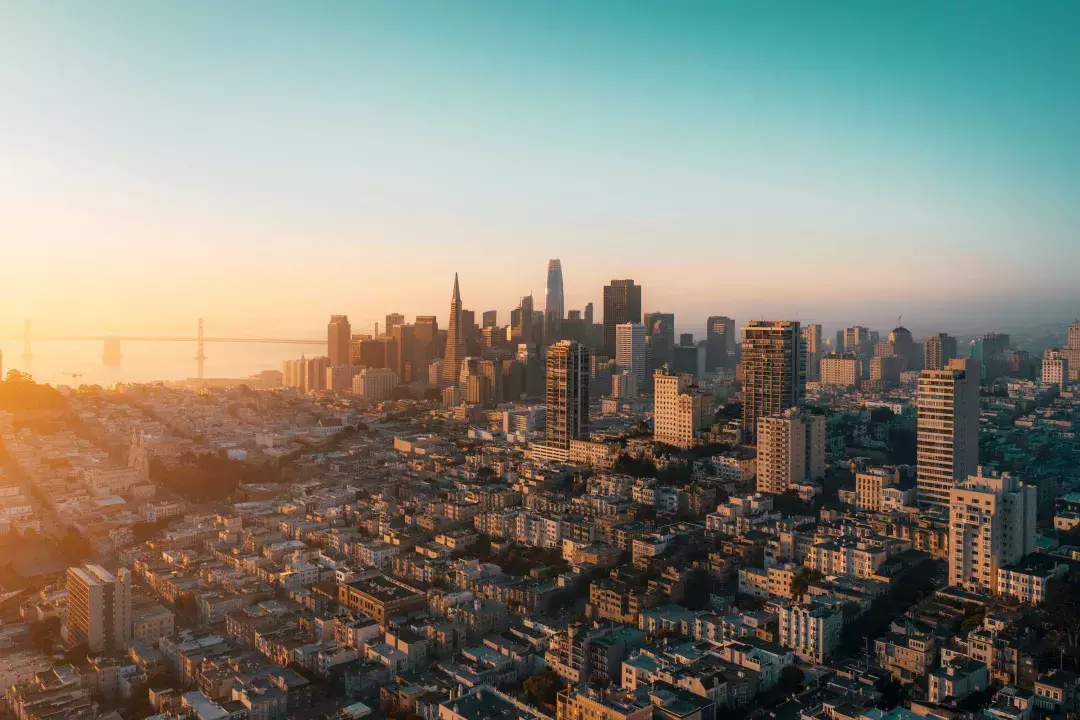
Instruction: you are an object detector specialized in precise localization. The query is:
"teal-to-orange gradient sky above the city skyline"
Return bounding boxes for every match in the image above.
[0,0,1080,335]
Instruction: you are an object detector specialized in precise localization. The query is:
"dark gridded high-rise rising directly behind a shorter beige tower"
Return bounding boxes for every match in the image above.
[742,320,806,445]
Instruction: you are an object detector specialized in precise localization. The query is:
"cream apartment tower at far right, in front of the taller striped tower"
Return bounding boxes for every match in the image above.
[948,467,1037,595]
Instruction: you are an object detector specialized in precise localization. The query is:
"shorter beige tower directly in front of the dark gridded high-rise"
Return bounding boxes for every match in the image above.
[757,408,825,494]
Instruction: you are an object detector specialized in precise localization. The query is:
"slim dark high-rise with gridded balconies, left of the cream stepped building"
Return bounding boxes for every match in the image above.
[544,340,589,448]
